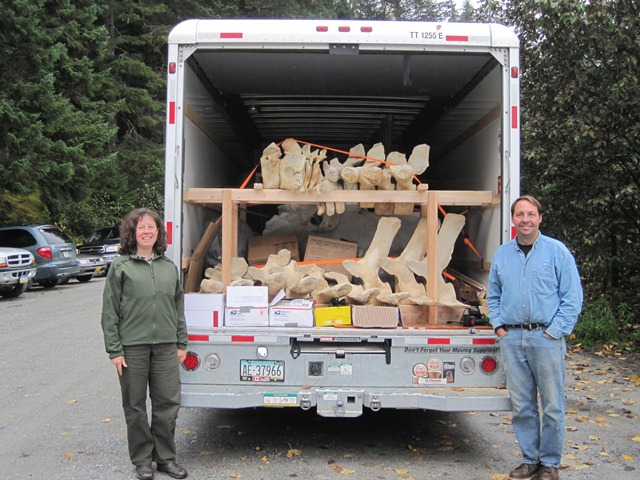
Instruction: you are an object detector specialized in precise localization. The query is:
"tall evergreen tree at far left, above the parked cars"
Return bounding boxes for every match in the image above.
[0,0,113,232]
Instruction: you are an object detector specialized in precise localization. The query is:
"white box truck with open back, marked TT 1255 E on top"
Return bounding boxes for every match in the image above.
[165,20,520,417]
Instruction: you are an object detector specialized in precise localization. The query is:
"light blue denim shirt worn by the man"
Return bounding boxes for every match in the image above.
[488,234,582,338]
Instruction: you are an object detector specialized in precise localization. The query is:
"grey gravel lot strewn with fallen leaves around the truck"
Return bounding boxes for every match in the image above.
[0,279,640,480]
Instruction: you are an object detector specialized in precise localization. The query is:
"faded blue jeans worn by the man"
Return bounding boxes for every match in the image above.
[499,328,566,468]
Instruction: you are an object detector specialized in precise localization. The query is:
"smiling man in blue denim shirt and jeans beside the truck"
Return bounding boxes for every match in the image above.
[488,196,582,480]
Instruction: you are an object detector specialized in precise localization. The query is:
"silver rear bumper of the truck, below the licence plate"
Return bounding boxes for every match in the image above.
[182,384,511,417]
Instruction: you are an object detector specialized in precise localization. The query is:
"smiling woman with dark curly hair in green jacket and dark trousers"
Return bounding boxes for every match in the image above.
[102,208,187,480]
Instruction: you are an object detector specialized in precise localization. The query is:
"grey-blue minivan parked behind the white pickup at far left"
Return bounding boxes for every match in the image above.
[0,225,80,288]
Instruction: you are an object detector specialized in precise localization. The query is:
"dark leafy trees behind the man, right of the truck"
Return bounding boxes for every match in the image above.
[483,0,640,308]
